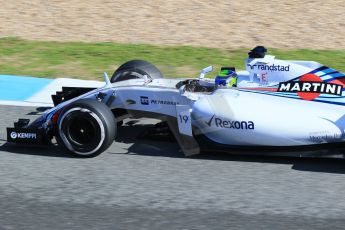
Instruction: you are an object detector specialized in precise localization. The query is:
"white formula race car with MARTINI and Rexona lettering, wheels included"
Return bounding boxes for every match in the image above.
[7,46,345,157]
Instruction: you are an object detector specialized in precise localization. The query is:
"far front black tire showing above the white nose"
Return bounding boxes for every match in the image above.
[110,60,163,82]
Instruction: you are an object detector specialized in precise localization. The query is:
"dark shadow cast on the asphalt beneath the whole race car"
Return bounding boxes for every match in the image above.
[0,124,345,174]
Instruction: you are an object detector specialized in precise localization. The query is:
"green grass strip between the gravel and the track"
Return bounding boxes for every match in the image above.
[0,37,345,79]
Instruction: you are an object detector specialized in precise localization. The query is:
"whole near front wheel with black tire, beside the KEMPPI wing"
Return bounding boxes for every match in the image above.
[56,99,116,157]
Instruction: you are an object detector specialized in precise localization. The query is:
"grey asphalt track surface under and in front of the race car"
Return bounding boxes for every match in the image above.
[0,106,345,230]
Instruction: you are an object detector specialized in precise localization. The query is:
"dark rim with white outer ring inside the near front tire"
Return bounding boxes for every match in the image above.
[59,108,105,155]
